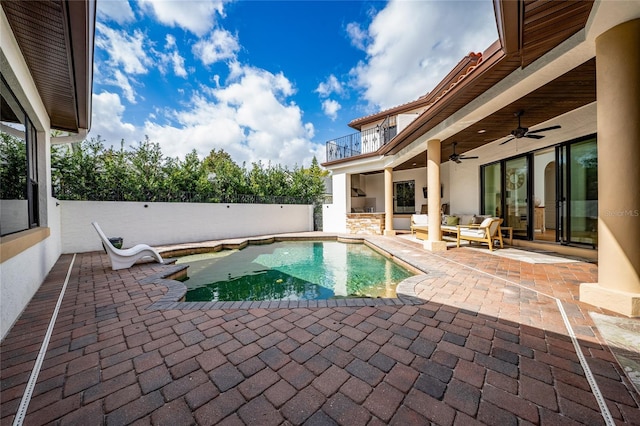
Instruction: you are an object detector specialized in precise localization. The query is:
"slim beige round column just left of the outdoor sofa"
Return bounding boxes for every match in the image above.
[423,139,447,251]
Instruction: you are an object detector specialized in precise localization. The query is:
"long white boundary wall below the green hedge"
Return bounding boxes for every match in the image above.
[60,201,313,253]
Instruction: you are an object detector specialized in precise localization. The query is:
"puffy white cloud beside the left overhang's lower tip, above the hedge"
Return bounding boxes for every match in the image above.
[89,91,142,146]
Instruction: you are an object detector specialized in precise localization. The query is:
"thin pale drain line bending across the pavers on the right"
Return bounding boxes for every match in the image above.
[428,253,615,426]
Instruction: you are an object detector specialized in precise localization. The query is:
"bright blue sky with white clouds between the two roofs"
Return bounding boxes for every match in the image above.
[89,0,497,167]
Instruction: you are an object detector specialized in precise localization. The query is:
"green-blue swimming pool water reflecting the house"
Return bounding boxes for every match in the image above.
[177,241,414,302]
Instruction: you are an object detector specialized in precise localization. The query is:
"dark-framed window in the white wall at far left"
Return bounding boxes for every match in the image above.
[0,78,39,235]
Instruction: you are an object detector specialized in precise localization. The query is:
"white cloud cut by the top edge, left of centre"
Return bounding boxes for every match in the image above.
[140,0,227,36]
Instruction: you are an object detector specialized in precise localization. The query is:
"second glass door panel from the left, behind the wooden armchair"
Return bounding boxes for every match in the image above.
[504,157,529,238]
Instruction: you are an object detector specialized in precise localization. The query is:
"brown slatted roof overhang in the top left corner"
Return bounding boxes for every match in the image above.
[2,0,96,133]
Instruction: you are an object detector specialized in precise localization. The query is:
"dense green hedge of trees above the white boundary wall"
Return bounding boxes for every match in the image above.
[51,137,327,203]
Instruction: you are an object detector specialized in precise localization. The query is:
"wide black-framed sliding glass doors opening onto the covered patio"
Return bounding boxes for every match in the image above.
[480,136,598,248]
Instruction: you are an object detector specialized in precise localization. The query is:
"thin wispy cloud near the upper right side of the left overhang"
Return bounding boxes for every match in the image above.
[96,23,153,74]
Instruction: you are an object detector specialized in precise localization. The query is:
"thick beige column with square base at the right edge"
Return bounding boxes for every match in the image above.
[580,19,640,317]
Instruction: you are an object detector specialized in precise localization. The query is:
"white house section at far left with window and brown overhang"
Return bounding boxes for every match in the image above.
[0,0,96,337]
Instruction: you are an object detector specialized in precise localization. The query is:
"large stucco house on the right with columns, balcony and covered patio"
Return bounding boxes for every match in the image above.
[323,0,640,316]
